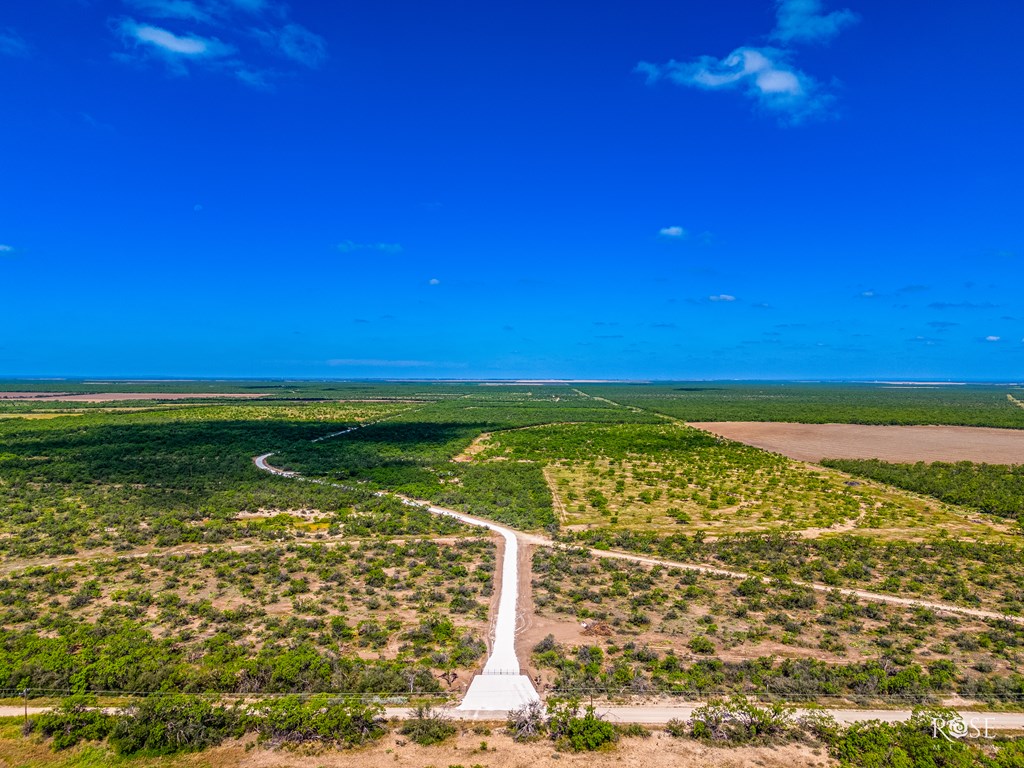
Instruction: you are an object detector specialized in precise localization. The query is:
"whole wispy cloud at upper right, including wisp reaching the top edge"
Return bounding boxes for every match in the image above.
[636,0,857,125]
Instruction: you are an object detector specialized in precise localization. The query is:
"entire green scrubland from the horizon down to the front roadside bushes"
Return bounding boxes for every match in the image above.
[0,382,1024,765]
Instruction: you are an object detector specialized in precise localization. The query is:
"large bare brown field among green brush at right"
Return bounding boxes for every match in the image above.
[690,422,1024,464]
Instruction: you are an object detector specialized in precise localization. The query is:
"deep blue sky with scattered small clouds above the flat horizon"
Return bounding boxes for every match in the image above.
[0,0,1024,380]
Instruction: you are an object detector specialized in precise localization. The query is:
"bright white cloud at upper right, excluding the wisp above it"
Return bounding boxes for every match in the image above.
[637,47,834,124]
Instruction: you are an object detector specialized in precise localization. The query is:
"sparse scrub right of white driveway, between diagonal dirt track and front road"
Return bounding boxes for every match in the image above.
[532,548,1024,705]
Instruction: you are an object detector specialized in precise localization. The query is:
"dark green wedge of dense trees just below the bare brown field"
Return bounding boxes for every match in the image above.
[821,459,1024,520]
